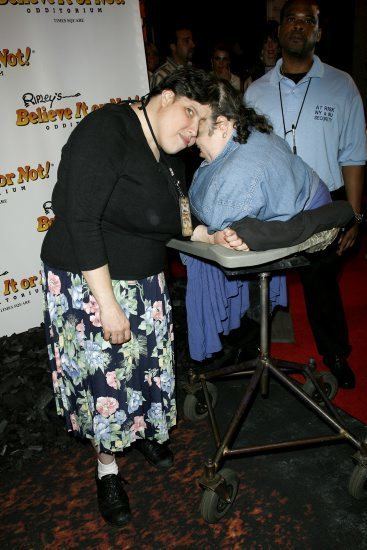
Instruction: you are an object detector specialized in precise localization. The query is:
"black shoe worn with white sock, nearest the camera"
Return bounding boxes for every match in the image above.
[96,474,131,527]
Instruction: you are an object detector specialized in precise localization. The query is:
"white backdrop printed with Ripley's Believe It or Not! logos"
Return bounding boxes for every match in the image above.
[0,0,148,336]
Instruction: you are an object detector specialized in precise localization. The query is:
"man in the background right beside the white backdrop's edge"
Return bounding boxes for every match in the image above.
[151,25,195,88]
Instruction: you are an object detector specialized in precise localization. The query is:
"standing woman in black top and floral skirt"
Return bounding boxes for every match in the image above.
[41,69,249,525]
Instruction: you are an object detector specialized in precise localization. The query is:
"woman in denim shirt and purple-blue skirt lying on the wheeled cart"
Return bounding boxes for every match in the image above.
[184,80,351,361]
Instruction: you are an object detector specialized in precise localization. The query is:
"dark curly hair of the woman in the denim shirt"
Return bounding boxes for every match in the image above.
[209,78,273,143]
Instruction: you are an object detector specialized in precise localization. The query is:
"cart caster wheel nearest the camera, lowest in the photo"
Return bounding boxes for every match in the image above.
[200,468,238,523]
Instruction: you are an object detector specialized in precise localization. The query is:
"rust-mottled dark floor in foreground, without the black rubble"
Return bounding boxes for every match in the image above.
[0,370,367,550]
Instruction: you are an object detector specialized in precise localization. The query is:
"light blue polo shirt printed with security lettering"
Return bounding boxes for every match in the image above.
[244,55,367,191]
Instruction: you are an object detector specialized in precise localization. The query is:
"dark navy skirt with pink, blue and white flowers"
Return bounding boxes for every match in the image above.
[43,265,176,452]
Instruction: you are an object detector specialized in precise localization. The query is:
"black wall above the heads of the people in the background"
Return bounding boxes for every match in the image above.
[146,0,355,73]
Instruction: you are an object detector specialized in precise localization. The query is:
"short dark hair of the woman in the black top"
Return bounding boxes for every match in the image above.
[149,67,213,105]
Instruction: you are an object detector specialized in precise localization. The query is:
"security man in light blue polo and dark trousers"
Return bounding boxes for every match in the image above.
[245,0,367,389]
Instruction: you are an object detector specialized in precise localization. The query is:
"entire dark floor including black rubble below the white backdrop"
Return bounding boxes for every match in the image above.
[0,284,367,550]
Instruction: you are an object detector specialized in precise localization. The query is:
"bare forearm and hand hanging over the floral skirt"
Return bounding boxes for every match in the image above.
[82,265,131,344]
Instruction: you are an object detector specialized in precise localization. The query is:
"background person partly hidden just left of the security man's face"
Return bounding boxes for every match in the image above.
[243,21,280,92]
